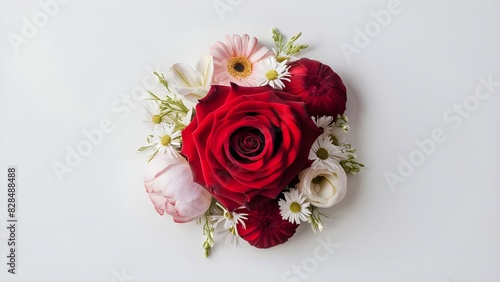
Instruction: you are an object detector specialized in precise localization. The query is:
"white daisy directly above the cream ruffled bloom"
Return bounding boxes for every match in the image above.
[309,136,347,170]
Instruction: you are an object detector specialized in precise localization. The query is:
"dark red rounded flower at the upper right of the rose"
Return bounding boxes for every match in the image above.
[283,58,347,118]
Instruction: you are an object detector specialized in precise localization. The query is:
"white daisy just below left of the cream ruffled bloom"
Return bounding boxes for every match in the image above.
[278,189,311,224]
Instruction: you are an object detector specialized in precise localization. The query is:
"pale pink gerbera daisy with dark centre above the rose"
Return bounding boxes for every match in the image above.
[210,34,272,86]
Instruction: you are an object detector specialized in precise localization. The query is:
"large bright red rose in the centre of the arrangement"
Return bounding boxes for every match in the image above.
[181,84,321,210]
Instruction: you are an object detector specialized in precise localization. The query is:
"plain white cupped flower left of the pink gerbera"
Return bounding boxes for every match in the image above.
[170,55,214,103]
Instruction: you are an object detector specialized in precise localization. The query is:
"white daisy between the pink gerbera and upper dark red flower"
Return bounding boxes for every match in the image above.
[255,57,291,89]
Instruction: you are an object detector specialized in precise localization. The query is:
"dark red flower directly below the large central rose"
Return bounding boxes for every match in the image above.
[237,201,299,249]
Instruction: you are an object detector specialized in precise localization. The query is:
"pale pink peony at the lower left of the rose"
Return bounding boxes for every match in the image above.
[144,152,212,223]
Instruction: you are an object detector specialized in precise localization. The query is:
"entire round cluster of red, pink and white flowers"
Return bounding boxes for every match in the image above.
[139,29,363,256]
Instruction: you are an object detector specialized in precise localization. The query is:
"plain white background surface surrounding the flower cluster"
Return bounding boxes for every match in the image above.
[0,0,500,282]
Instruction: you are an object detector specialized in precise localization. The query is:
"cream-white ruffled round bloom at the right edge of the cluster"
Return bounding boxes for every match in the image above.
[295,164,347,208]
